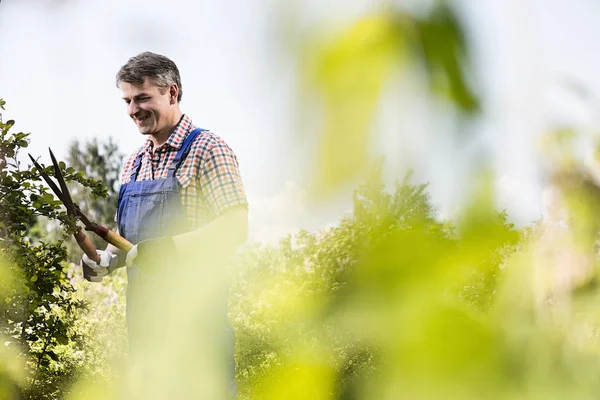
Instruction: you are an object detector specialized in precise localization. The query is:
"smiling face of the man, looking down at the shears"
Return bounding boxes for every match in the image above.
[121,78,174,135]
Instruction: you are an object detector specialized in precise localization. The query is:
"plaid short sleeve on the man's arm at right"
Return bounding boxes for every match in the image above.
[199,139,248,215]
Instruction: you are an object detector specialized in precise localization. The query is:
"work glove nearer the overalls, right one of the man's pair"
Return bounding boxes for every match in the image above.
[125,236,177,268]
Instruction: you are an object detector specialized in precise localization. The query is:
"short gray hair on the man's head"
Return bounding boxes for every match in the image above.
[117,51,183,102]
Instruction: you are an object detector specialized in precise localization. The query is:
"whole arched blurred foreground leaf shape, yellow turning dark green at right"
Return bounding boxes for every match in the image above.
[306,5,478,192]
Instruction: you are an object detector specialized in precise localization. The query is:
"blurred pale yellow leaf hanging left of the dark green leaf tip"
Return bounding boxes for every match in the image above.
[313,14,405,195]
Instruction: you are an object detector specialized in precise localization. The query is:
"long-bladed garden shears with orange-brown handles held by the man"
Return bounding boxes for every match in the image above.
[28,148,133,262]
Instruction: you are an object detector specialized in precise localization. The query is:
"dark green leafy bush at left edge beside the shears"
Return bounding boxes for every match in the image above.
[0,100,113,399]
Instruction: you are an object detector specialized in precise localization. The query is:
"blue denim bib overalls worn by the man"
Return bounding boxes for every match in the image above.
[117,129,235,394]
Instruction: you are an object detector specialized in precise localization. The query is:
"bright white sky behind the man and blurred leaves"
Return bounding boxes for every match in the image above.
[0,0,600,240]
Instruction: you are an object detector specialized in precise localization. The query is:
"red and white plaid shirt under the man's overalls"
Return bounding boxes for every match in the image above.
[121,115,248,229]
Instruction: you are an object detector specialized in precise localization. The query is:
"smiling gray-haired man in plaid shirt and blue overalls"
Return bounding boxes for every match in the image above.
[82,52,248,398]
